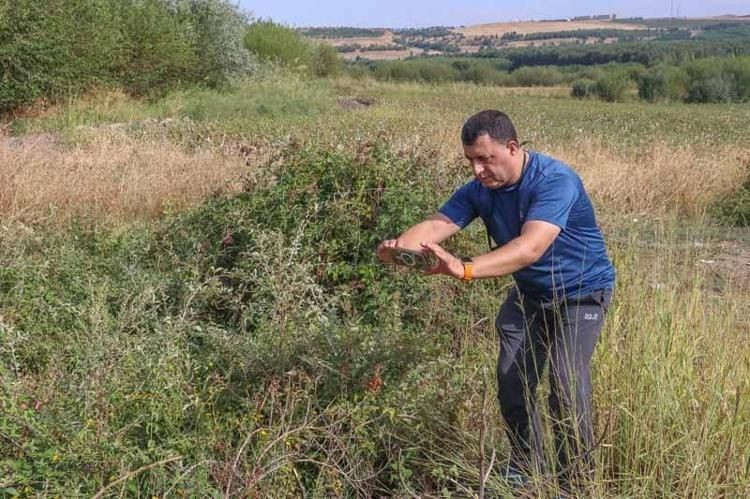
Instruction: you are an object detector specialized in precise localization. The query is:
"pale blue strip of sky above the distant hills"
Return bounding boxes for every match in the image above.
[238,0,750,28]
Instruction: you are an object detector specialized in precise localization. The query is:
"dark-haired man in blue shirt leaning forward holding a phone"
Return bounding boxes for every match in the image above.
[377,110,615,488]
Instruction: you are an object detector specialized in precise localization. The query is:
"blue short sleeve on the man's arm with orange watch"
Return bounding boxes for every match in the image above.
[526,174,579,229]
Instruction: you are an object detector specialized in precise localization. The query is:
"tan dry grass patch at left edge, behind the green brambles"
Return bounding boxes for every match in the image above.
[0,132,247,225]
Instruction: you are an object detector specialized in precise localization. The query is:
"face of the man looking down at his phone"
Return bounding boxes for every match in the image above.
[464,134,520,189]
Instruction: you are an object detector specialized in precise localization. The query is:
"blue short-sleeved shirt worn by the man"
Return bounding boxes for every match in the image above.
[439,151,615,299]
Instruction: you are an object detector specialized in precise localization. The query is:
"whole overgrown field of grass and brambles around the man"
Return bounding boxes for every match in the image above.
[0,74,750,497]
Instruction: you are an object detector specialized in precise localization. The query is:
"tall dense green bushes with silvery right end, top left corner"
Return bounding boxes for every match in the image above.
[0,0,252,112]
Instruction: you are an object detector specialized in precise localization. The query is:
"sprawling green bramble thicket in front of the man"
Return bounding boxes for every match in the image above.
[0,145,498,496]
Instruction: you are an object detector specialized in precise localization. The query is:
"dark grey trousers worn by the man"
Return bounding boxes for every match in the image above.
[495,289,611,483]
